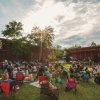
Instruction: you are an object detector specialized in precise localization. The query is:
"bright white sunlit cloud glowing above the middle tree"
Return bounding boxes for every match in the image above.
[23,0,65,32]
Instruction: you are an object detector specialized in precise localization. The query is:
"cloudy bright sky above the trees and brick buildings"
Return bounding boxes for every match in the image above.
[0,0,100,47]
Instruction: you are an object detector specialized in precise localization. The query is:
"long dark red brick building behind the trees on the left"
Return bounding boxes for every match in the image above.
[0,38,51,61]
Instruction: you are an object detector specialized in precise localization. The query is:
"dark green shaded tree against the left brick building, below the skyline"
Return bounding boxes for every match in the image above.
[11,37,32,59]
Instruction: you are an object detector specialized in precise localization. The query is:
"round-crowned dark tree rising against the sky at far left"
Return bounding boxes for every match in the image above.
[2,21,23,39]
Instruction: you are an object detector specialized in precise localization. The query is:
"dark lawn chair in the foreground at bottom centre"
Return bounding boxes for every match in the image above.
[40,83,59,100]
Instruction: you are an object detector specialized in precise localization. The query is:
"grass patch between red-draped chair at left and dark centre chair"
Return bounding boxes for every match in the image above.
[15,83,39,100]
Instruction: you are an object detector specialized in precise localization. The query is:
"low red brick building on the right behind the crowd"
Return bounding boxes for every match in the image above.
[70,46,100,60]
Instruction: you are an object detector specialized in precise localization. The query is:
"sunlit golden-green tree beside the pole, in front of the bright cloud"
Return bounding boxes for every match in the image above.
[28,26,54,48]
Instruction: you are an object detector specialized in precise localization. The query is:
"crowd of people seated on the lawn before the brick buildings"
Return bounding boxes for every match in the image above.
[0,60,100,99]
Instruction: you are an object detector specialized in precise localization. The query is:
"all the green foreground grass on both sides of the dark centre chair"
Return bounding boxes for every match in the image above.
[15,81,100,100]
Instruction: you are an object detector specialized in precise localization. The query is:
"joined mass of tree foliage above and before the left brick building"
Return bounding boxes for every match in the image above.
[2,21,54,60]
